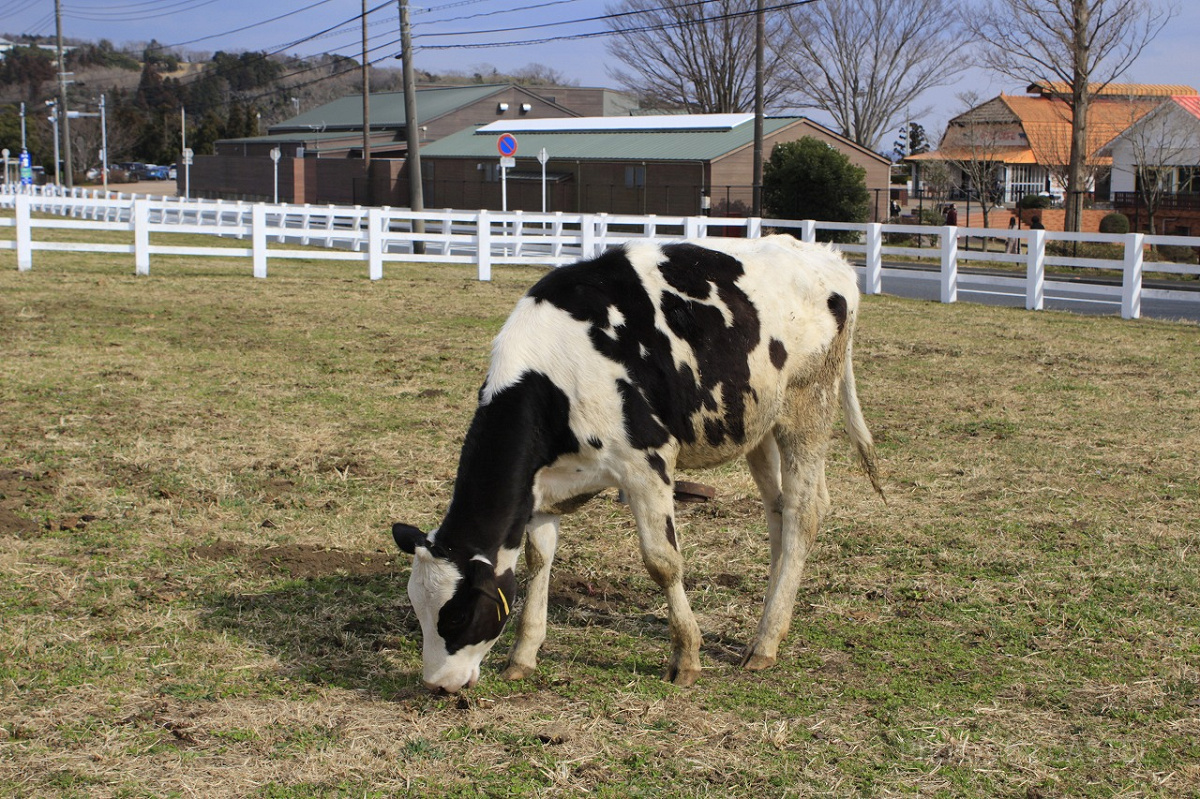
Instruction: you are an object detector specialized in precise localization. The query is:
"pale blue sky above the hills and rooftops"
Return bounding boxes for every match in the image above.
[0,0,1200,136]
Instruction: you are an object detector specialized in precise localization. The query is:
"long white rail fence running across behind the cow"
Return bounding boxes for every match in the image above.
[0,184,1200,319]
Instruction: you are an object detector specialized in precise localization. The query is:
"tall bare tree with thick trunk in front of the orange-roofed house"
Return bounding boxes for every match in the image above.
[962,0,1174,230]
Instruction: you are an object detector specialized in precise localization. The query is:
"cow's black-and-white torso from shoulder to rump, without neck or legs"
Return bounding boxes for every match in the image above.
[484,236,858,468]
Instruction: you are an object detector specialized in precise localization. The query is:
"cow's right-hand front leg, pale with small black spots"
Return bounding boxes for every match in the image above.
[629,467,701,687]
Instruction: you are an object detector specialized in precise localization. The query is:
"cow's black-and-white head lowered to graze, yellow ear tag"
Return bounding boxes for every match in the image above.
[391,523,516,693]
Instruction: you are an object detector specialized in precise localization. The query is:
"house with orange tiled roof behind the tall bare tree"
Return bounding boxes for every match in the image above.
[905,83,1198,218]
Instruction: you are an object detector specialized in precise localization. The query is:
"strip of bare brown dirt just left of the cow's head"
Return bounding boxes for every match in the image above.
[192,541,400,579]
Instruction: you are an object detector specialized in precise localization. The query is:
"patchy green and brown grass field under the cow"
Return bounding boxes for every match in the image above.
[0,252,1200,799]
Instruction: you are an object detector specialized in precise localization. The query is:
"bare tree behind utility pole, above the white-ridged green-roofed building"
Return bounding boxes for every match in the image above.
[608,0,786,114]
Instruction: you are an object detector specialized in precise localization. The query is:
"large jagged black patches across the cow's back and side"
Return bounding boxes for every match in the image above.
[529,244,761,449]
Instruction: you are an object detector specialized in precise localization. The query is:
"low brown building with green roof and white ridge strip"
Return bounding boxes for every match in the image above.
[421,114,890,218]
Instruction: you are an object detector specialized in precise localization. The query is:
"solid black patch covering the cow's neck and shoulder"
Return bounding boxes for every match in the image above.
[436,372,580,560]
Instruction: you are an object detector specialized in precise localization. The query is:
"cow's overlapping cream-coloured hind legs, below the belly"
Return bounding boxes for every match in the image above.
[742,431,828,671]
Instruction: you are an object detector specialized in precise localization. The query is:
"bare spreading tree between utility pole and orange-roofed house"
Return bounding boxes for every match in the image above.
[780,0,967,150]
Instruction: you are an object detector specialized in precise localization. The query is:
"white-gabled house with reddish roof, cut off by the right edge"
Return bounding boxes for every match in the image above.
[1100,95,1200,235]
